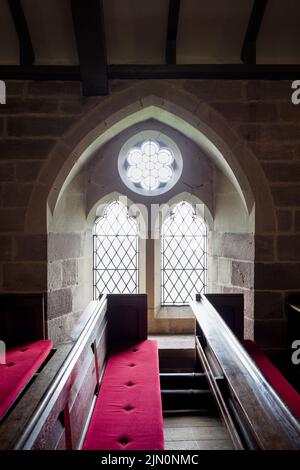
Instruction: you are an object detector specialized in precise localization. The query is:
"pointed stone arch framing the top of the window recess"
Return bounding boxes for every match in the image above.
[25,82,275,233]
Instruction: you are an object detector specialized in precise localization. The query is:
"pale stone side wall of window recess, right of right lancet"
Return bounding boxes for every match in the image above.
[208,169,254,339]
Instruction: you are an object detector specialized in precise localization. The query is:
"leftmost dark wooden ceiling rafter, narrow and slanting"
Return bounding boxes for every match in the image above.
[8,0,35,65]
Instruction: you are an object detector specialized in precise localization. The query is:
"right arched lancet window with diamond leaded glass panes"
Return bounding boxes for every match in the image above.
[161,201,207,305]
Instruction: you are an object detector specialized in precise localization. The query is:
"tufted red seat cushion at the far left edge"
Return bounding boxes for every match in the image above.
[0,340,53,418]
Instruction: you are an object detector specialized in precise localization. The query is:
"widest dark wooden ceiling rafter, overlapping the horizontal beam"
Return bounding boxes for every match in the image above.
[71,0,108,96]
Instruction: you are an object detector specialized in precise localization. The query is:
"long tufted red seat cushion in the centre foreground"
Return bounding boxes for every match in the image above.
[83,340,164,450]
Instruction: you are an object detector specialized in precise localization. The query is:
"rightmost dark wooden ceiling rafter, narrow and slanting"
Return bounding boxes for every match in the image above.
[241,0,267,64]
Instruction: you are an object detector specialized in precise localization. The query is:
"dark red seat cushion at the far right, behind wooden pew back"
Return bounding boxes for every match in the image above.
[243,340,300,418]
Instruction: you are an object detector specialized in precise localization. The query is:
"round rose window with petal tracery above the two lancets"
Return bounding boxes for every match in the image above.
[119,134,182,196]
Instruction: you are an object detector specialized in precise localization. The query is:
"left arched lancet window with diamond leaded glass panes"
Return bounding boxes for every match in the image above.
[93,201,139,299]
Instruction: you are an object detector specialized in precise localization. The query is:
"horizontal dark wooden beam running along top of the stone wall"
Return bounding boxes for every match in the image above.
[0,64,300,80]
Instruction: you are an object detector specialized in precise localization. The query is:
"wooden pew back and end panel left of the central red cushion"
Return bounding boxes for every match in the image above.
[0,294,152,450]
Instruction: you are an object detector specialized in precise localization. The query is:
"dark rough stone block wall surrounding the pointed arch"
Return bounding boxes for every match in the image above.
[0,80,300,354]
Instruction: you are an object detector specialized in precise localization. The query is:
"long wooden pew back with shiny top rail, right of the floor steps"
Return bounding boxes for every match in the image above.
[191,295,300,449]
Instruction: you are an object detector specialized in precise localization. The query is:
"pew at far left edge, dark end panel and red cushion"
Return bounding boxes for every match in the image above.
[0,293,53,422]
